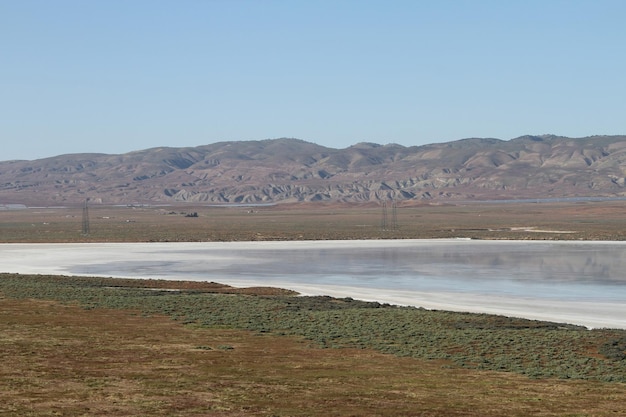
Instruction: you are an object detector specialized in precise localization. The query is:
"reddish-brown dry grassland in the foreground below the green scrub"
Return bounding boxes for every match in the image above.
[0,298,626,417]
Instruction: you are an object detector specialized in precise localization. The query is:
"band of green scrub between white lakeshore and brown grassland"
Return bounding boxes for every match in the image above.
[0,274,626,382]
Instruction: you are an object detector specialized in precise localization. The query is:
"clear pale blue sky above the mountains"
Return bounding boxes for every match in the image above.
[0,0,626,160]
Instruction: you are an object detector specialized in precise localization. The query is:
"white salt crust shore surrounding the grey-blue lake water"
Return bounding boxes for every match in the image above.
[0,239,626,329]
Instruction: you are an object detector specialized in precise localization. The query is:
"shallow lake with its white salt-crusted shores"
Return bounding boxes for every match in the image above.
[0,239,626,328]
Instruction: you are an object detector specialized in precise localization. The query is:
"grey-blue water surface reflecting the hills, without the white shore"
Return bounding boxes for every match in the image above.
[71,240,626,301]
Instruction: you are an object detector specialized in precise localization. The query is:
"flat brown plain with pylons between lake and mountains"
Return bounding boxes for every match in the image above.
[0,201,626,243]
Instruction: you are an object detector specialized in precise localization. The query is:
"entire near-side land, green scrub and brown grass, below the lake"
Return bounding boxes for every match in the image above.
[0,274,626,416]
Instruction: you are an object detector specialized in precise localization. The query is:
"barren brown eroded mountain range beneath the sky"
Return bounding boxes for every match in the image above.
[0,135,626,206]
